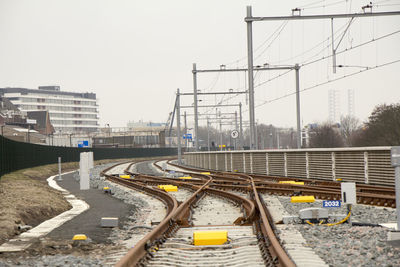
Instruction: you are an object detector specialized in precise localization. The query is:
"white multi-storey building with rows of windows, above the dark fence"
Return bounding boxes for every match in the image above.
[0,86,99,133]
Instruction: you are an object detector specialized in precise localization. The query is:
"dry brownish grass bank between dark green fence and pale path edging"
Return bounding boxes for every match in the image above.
[0,159,144,244]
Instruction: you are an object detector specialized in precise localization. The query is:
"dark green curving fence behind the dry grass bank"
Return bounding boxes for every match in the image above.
[0,136,177,177]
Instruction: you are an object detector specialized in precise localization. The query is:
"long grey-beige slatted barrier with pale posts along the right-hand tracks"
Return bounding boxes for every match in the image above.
[184,147,394,186]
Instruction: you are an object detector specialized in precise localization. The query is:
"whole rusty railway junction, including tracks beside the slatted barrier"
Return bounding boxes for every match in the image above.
[103,158,395,266]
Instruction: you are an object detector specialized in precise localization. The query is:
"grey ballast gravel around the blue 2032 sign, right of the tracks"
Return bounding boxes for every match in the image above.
[277,197,400,266]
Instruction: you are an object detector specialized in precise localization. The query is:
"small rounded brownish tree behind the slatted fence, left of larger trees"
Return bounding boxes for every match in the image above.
[310,123,343,147]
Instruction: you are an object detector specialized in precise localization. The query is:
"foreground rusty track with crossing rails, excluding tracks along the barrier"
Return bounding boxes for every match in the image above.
[103,160,295,266]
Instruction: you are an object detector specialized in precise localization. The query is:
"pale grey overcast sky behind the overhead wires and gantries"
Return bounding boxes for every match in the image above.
[0,0,400,130]
